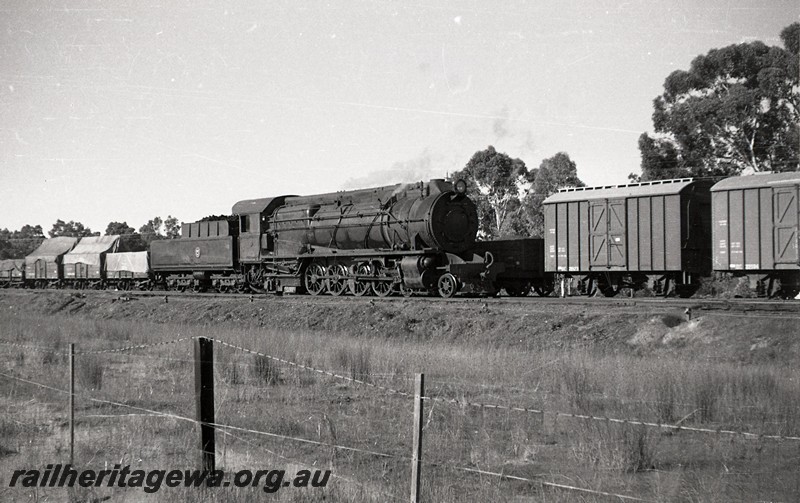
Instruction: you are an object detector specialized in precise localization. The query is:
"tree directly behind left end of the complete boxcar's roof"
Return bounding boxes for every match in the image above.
[522,152,586,237]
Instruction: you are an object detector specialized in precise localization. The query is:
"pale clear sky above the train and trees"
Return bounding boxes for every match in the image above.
[0,0,800,232]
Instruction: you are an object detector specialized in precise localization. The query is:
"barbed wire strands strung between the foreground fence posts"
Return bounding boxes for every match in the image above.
[0,336,800,501]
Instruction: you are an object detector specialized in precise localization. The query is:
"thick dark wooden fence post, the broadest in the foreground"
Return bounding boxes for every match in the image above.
[194,337,216,470]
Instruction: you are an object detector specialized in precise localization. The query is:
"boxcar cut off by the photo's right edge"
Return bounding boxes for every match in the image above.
[711,172,800,296]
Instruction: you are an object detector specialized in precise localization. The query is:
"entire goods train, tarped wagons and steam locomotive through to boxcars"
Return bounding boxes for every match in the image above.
[0,173,800,297]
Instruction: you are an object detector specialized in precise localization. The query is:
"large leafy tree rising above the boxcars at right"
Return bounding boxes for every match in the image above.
[633,23,800,180]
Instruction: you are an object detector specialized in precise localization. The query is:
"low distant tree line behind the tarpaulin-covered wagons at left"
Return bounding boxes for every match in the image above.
[0,215,181,259]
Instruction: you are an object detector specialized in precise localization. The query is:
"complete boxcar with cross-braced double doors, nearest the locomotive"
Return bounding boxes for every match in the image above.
[544,178,713,296]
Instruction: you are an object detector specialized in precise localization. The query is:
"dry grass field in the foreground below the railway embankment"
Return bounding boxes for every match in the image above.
[0,298,800,502]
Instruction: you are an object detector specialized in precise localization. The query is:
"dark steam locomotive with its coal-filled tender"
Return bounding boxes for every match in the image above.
[150,180,503,297]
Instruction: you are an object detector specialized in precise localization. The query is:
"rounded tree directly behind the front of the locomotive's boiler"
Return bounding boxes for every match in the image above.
[452,145,530,238]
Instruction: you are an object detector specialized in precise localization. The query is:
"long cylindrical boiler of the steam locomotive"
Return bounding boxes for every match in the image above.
[268,180,478,255]
